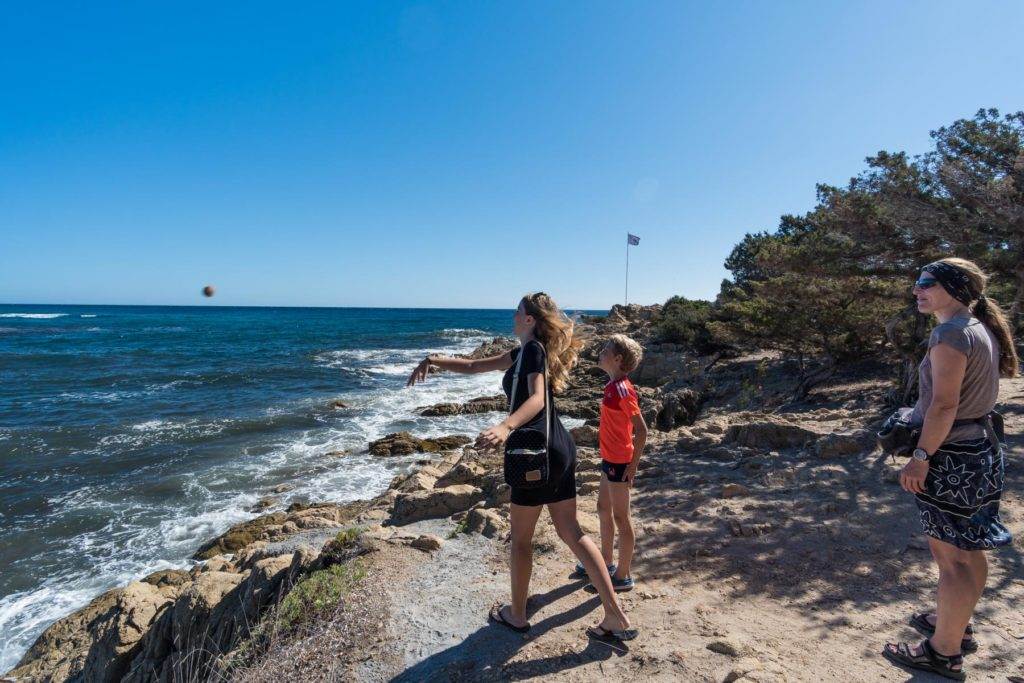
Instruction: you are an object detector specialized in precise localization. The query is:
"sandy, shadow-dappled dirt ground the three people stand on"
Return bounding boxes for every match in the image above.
[354,380,1024,681]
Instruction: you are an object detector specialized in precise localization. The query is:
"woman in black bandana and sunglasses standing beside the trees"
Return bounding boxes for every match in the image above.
[883,258,1018,680]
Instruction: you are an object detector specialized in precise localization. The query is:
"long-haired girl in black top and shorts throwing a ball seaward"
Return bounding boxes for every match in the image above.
[408,292,637,640]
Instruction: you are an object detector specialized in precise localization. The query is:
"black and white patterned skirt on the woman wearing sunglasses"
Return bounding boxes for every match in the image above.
[915,437,1013,550]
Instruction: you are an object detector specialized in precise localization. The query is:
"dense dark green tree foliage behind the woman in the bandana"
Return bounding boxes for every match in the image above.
[665,110,1024,388]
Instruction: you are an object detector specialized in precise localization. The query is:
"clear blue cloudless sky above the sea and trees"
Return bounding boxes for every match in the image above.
[0,1,1024,308]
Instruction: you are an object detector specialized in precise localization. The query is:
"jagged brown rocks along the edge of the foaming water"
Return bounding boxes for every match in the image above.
[4,306,679,682]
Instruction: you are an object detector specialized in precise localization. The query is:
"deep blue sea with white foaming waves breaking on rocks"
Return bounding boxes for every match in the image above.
[0,304,603,672]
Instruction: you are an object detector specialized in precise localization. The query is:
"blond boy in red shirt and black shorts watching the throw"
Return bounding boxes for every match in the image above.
[577,335,647,592]
